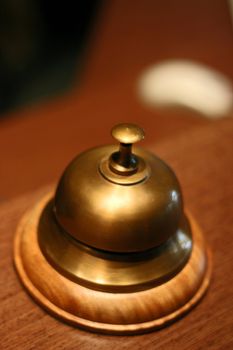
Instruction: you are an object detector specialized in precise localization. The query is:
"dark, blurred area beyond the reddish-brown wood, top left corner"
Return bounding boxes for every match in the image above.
[0,0,101,115]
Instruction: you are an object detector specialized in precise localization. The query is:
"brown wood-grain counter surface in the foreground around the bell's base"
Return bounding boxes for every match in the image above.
[0,119,233,350]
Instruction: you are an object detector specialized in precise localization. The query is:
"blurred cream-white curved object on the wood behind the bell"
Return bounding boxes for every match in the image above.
[139,60,233,118]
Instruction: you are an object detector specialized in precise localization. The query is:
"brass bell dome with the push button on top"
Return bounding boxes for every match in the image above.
[54,124,183,253]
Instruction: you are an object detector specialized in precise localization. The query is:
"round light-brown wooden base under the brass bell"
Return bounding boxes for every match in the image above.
[14,196,211,334]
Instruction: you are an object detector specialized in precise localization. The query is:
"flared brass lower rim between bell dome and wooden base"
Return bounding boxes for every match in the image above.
[38,200,192,292]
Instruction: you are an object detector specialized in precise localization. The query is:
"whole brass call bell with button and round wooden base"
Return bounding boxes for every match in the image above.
[14,124,211,334]
